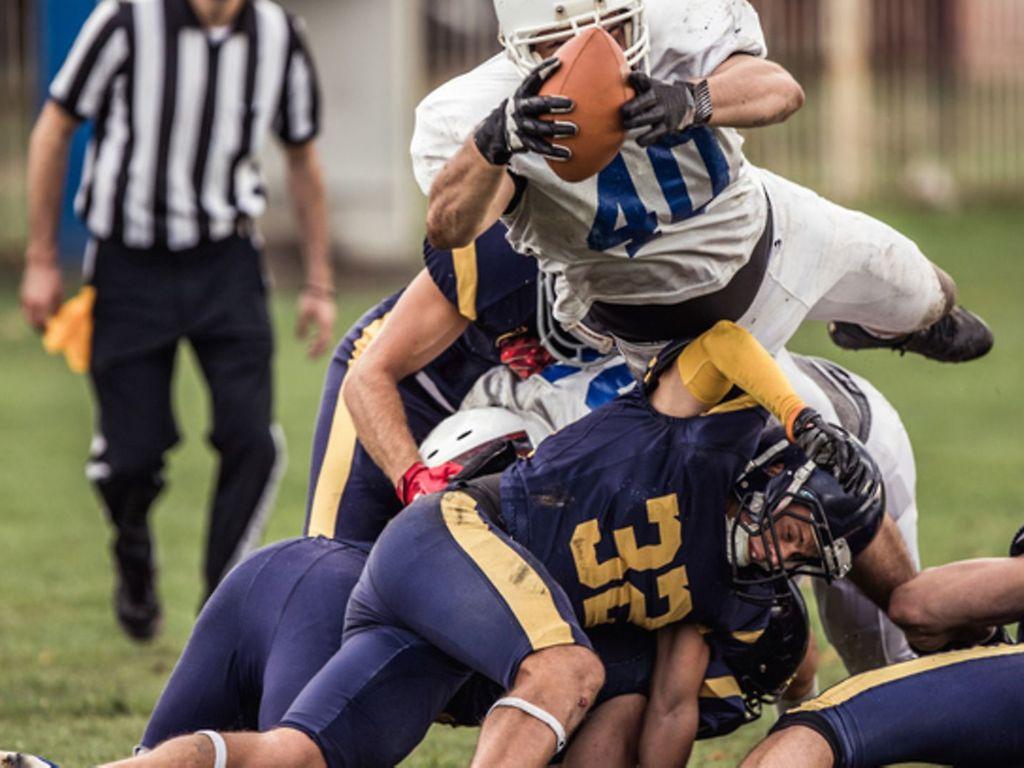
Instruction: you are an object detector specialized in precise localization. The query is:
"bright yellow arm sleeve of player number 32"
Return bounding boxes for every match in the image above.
[676,321,806,434]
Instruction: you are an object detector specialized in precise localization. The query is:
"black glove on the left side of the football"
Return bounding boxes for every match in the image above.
[473,58,577,165]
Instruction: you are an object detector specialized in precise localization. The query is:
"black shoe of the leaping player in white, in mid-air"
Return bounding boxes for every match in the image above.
[828,306,994,362]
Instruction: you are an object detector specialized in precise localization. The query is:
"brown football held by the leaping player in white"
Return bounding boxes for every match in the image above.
[541,27,633,182]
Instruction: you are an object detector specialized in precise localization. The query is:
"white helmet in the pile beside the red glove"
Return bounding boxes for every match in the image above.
[420,408,534,467]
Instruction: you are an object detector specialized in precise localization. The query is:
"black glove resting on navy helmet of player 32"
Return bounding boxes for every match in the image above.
[793,408,882,498]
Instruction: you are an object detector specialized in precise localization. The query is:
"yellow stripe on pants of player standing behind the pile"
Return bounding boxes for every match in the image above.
[307,312,390,539]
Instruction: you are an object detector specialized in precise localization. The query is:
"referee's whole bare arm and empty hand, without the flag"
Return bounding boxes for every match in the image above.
[286,141,335,357]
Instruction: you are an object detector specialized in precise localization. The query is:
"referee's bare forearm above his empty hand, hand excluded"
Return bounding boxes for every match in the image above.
[288,144,334,290]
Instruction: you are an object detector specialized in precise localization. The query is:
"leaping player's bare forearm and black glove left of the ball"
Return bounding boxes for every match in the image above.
[427,58,577,248]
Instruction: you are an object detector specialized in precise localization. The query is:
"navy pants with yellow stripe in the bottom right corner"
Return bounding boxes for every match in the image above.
[774,645,1024,768]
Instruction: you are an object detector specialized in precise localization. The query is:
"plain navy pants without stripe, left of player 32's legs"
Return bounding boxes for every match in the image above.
[141,538,366,749]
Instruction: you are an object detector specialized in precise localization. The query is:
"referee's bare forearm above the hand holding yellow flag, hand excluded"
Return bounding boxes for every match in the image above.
[26,102,77,264]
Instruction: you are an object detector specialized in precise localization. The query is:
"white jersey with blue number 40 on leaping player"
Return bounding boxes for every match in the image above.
[412,0,767,326]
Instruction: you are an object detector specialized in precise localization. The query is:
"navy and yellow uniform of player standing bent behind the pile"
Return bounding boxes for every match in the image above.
[303,224,538,542]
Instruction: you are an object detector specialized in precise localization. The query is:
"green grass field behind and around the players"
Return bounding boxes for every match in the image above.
[0,204,1024,768]
